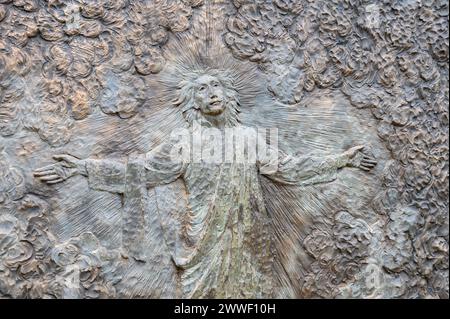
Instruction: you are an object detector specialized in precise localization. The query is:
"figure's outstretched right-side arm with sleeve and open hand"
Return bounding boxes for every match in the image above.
[260,145,376,186]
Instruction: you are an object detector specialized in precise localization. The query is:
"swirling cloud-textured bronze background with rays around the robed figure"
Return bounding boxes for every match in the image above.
[0,0,449,298]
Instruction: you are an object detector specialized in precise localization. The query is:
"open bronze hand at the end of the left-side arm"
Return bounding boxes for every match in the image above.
[33,155,85,184]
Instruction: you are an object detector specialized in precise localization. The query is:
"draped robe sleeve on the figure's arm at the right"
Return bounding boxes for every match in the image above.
[258,146,347,186]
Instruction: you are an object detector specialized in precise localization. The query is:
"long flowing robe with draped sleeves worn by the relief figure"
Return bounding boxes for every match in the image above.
[82,126,345,298]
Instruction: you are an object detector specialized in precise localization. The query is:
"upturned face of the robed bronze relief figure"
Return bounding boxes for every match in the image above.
[194,74,226,116]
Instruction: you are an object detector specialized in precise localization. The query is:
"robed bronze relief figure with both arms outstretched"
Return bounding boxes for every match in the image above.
[34,70,376,298]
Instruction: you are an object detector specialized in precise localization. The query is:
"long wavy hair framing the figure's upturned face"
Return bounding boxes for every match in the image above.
[173,69,240,127]
